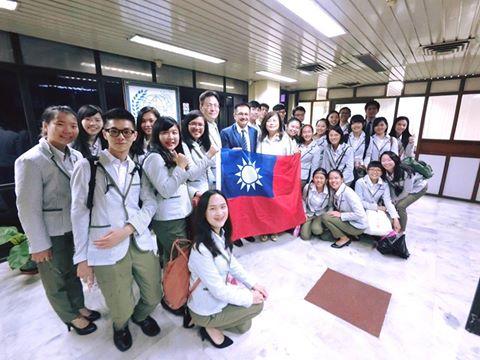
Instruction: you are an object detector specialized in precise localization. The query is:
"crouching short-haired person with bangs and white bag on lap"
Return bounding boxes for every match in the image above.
[355,161,401,232]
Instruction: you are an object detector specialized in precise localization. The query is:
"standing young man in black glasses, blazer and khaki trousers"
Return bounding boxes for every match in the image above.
[71,108,161,351]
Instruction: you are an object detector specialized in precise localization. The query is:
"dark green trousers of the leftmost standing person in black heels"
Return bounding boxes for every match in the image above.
[37,232,85,323]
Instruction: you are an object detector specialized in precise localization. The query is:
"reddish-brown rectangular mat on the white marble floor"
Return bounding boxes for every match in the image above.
[305,269,392,337]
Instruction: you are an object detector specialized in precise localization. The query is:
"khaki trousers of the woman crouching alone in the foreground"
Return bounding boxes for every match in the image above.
[189,303,263,334]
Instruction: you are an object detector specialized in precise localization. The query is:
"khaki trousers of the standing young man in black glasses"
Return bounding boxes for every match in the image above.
[93,240,162,330]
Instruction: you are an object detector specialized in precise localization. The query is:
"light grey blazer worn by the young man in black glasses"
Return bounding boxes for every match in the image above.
[71,150,157,266]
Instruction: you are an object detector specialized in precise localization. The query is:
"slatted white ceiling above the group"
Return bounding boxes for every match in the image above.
[0,0,480,89]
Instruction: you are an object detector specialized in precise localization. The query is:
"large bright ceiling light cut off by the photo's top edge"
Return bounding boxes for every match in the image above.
[277,0,346,37]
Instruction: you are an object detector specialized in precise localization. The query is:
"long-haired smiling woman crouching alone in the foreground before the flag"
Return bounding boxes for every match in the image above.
[188,190,268,348]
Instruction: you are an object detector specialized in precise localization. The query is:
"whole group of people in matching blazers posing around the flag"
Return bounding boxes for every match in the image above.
[15,91,426,351]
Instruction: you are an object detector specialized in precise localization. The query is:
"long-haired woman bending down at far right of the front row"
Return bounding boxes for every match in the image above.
[380,151,428,233]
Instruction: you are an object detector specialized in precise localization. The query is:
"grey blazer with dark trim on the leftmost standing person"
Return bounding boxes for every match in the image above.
[15,138,82,253]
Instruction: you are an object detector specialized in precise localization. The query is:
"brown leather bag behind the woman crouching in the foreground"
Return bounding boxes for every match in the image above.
[162,239,200,310]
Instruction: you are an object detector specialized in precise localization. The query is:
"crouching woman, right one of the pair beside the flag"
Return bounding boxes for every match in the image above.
[322,170,368,248]
